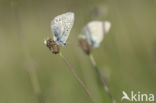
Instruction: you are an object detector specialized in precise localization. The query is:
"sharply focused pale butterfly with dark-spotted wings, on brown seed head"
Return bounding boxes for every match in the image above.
[51,12,74,46]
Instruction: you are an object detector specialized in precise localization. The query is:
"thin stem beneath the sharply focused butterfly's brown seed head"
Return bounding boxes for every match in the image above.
[60,53,96,103]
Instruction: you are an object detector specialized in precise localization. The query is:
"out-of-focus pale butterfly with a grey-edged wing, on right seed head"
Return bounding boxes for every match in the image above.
[83,21,111,47]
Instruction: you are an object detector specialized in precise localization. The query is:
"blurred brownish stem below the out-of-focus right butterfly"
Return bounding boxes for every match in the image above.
[89,53,116,103]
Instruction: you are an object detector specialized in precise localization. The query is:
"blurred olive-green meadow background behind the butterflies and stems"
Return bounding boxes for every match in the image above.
[0,0,156,103]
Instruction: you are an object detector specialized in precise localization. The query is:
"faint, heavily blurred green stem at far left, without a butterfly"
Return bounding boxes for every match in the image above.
[11,0,44,103]
